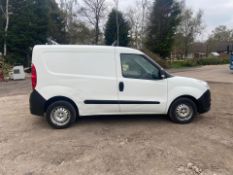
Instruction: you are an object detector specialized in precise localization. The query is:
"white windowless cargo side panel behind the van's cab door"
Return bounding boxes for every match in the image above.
[33,47,118,115]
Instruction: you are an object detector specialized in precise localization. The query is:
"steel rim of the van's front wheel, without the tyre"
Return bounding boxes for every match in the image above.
[176,104,193,120]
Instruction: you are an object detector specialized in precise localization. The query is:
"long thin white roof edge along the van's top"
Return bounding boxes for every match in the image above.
[33,45,142,54]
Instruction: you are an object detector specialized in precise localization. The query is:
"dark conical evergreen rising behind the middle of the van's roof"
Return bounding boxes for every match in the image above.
[105,9,129,46]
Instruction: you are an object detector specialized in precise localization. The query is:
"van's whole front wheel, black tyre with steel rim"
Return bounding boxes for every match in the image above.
[169,98,197,124]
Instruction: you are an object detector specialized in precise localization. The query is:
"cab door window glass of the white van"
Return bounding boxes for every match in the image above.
[121,54,160,80]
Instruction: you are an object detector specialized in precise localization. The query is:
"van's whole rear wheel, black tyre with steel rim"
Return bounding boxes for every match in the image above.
[46,101,77,129]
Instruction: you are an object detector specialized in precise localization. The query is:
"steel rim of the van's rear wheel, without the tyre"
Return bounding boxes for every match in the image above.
[50,106,71,126]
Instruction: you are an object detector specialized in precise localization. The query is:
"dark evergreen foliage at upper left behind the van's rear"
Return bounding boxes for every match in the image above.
[0,0,68,66]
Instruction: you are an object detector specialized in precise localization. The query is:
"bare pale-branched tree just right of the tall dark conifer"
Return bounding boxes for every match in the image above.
[176,7,204,56]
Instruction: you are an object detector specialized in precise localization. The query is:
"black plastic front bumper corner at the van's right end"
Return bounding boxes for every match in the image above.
[197,90,211,114]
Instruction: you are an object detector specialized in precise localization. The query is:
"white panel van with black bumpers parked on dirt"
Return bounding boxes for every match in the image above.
[30,45,211,128]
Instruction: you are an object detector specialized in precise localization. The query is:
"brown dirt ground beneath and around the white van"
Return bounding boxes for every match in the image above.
[0,66,233,175]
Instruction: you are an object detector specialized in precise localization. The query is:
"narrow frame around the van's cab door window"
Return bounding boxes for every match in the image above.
[120,53,164,81]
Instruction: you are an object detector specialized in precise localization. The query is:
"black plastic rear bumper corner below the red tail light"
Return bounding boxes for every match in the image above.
[29,90,46,116]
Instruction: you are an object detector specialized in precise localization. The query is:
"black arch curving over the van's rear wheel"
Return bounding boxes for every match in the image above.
[44,96,79,115]
